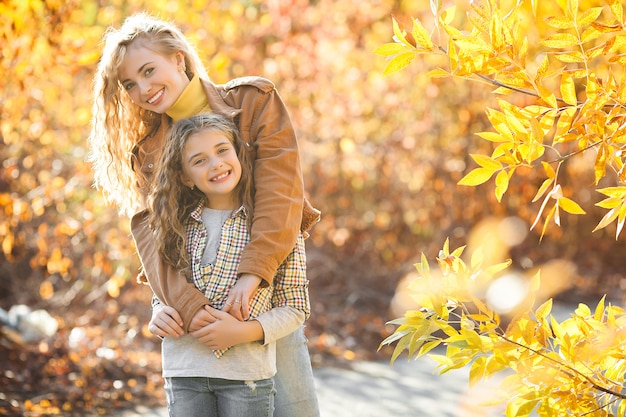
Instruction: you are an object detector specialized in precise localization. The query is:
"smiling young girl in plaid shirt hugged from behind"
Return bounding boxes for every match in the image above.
[149,114,309,417]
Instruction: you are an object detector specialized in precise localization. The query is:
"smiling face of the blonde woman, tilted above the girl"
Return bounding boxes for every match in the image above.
[118,41,189,114]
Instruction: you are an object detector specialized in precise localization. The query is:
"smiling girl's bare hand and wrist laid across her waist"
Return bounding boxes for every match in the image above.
[189,306,264,350]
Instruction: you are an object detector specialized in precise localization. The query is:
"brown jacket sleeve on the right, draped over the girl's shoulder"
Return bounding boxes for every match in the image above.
[230,82,304,283]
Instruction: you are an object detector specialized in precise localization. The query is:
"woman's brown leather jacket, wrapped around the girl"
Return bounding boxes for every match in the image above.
[131,77,320,330]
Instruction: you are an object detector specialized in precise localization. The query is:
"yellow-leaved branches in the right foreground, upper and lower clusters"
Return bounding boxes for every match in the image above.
[377,0,626,417]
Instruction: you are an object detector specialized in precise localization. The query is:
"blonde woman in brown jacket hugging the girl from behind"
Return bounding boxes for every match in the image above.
[89,14,319,417]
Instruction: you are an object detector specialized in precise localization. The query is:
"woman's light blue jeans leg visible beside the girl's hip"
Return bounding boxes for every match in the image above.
[274,326,320,417]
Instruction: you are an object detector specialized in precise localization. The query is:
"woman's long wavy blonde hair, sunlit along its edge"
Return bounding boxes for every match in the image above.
[88,13,209,215]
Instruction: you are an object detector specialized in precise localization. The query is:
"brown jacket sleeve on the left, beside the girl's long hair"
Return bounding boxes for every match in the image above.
[131,210,209,332]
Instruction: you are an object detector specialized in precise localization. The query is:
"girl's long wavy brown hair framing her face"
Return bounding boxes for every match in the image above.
[148,113,254,277]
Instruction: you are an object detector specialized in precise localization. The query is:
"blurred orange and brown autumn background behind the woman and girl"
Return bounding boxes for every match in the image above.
[0,0,626,415]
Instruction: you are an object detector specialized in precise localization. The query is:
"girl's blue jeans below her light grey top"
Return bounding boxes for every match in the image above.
[165,377,276,417]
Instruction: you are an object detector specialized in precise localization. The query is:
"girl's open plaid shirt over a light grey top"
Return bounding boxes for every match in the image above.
[186,204,310,358]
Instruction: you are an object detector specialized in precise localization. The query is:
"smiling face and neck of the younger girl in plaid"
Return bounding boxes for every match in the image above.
[182,130,241,210]
